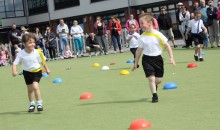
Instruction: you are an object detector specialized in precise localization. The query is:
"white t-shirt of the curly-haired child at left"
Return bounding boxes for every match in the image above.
[13,49,46,71]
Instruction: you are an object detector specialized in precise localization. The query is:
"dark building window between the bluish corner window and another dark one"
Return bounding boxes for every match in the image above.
[28,0,48,15]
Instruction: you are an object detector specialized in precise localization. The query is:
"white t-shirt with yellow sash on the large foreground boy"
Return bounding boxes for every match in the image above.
[138,30,168,56]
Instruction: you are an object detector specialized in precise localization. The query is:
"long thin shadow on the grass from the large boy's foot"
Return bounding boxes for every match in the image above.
[79,98,151,106]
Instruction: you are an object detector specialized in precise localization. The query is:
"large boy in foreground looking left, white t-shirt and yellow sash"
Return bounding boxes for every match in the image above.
[132,13,176,103]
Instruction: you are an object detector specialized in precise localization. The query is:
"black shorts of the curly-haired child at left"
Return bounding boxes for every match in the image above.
[23,70,42,85]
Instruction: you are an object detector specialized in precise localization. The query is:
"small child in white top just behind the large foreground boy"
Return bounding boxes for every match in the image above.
[126,24,140,68]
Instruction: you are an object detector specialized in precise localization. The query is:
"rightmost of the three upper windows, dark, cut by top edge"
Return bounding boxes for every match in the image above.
[54,0,80,10]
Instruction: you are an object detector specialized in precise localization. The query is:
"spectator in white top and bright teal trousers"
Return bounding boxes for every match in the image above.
[71,20,83,57]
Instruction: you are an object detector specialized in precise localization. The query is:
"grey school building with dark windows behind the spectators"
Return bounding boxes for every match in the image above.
[0,0,218,42]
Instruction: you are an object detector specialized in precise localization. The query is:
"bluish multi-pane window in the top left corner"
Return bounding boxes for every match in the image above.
[0,0,24,18]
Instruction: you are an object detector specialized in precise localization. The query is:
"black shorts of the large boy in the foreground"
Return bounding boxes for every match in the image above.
[142,55,164,77]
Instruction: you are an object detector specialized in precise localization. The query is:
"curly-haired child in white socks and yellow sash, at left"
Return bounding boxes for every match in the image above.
[12,34,50,112]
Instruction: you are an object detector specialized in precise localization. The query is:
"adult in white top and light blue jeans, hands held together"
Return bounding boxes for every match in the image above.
[57,19,69,58]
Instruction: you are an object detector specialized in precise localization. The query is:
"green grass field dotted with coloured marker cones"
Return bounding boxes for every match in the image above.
[0,48,220,130]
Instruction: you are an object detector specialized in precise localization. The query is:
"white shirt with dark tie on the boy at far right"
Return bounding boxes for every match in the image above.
[188,19,205,33]
